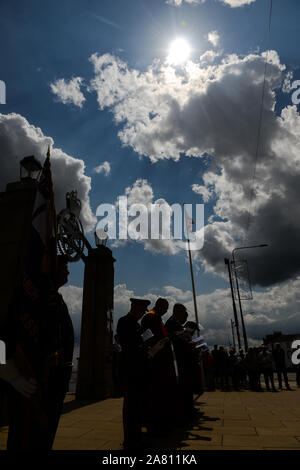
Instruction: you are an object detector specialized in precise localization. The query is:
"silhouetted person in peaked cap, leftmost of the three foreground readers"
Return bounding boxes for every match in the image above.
[117,298,151,450]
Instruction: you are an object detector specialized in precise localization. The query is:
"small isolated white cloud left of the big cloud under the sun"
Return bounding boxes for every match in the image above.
[50,77,86,108]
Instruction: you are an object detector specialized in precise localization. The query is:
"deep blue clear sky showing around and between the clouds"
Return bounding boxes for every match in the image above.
[0,0,300,346]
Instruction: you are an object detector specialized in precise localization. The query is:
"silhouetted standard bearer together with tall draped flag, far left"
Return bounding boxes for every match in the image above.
[3,149,74,450]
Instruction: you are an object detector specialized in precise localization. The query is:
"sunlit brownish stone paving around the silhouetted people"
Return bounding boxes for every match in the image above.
[0,383,300,451]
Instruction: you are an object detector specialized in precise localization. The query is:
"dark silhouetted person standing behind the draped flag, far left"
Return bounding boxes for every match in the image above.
[3,256,74,450]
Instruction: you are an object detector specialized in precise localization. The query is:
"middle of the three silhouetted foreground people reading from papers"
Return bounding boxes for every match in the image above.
[141,298,179,436]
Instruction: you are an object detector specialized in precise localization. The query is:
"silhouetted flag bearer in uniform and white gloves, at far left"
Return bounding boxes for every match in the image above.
[3,256,74,450]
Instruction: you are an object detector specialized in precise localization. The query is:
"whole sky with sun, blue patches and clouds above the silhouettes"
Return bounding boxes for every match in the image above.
[0,0,300,344]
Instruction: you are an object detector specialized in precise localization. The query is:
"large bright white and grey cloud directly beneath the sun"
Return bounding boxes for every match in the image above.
[91,52,282,162]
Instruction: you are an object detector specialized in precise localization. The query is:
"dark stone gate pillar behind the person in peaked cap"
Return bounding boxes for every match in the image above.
[76,245,115,400]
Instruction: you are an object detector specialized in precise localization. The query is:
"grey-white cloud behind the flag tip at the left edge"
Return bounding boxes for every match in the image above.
[0,113,96,231]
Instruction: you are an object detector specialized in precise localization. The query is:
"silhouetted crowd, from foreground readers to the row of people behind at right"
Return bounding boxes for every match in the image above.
[115,298,291,449]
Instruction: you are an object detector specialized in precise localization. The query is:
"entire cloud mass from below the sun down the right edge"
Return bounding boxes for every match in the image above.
[86,51,300,285]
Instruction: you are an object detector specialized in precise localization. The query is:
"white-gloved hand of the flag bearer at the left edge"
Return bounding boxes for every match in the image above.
[0,359,37,398]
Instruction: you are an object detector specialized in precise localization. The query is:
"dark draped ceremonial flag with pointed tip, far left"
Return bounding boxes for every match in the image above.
[19,145,57,373]
